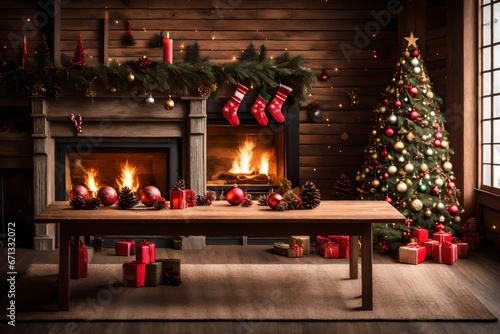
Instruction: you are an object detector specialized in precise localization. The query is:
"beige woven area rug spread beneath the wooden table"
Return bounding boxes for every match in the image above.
[6,264,496,321]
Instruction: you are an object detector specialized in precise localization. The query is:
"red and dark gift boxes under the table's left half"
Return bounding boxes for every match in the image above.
[115,240,182,288]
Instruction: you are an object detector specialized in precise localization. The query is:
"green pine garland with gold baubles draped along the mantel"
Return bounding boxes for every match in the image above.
[2,43,316,102]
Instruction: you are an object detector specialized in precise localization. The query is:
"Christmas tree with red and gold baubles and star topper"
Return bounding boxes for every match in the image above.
[356,33,463,252]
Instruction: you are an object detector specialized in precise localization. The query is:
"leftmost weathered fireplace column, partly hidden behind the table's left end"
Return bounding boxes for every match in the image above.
[31,97,56,250]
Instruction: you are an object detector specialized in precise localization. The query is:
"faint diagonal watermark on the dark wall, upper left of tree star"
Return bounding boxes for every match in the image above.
[340,0,403,63]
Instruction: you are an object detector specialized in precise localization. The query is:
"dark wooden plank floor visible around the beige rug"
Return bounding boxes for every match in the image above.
[0,246,500,334]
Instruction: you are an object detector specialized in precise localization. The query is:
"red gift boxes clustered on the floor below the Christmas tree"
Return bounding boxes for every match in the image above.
[398,219,479,264]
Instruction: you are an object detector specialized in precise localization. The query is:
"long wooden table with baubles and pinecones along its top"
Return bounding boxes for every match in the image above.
[35,201,405,310]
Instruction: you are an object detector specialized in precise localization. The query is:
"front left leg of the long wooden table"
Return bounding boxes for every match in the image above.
[59,224,71,311]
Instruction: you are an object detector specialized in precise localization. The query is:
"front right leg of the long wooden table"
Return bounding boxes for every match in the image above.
[361,224,373,310]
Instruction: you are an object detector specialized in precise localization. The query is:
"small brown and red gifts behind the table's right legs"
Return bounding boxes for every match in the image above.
[274,235,349,259]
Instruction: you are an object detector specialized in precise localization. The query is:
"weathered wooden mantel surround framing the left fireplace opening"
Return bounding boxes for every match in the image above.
[31,97,207,250]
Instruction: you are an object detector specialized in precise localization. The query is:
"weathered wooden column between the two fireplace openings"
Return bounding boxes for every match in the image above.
[182,97,207,195]
